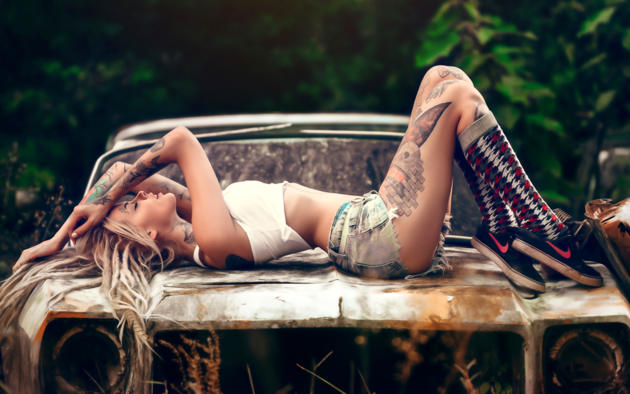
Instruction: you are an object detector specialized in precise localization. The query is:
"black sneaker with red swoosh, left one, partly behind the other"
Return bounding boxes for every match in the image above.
[470,225,545,293]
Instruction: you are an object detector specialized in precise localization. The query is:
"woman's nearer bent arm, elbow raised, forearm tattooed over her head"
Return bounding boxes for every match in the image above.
[69,127,247,266]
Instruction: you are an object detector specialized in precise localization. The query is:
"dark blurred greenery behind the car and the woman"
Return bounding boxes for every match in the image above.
[0,0,630,277]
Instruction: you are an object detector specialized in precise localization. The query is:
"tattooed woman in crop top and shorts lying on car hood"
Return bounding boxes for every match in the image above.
[14,66,602,291]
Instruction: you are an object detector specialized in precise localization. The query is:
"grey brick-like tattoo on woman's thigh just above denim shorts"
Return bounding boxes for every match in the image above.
[381,141,425,216]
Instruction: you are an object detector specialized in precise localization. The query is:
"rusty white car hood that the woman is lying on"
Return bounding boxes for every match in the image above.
[20,247,630,342]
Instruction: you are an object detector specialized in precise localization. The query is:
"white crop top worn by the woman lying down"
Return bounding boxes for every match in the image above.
[223,181,311,263]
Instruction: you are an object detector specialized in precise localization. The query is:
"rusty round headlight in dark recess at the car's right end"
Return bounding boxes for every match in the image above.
[543,325,628,393]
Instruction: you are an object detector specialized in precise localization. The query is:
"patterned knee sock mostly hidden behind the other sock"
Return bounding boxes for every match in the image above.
[455,147,518,233]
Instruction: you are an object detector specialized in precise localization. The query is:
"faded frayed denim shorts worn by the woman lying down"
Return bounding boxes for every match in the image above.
[328,191,408,279]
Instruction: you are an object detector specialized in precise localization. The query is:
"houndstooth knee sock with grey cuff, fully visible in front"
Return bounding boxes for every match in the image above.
[458,113,566,240]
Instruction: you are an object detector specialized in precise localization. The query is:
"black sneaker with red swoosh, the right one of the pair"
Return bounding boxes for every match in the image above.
[512,228,604,287]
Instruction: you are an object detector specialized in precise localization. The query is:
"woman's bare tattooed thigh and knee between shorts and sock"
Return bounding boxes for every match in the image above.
[379,66,487,272]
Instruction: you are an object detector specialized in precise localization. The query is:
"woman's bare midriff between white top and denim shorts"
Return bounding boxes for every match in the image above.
[284,183,356,251]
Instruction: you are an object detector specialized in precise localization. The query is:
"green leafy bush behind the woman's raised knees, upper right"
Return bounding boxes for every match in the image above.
[416,0,630,213]
